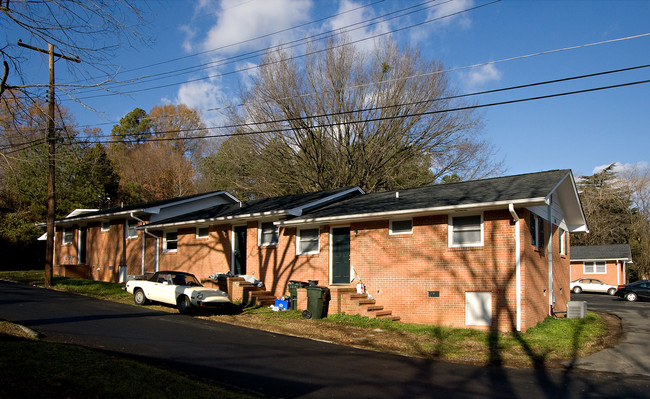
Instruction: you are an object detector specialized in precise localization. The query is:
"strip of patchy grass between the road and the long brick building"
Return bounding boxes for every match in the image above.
[0,271,620,374]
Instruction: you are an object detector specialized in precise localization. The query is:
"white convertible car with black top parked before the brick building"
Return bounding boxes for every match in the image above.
[125,272,230,313]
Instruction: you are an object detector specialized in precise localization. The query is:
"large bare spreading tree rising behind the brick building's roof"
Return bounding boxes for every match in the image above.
[223,41,501,195]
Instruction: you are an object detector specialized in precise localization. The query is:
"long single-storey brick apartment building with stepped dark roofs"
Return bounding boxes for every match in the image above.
[55,170,587,331]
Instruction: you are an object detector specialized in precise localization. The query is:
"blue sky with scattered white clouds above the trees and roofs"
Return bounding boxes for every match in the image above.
[8,0,650,180]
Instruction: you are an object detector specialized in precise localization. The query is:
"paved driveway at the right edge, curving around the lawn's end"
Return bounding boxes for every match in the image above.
[560,293,650,376]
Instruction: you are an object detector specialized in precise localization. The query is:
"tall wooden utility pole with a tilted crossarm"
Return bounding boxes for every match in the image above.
[18,41,81,287]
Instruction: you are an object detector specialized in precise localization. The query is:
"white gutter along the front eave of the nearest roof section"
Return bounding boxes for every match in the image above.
[276,197,546,226]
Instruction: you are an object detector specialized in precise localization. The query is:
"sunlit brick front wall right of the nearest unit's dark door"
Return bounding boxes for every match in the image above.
[344,210,515,330]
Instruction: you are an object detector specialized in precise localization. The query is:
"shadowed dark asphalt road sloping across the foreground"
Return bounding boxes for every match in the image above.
[0,282,650,398]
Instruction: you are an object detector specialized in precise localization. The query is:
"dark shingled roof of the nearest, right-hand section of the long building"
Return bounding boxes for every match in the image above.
[294,169,570,219]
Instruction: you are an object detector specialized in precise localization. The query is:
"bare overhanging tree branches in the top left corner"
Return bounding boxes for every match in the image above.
[0,0,144,102]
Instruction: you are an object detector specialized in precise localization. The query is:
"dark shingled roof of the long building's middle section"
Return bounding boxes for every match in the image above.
[147,187,361,227]
